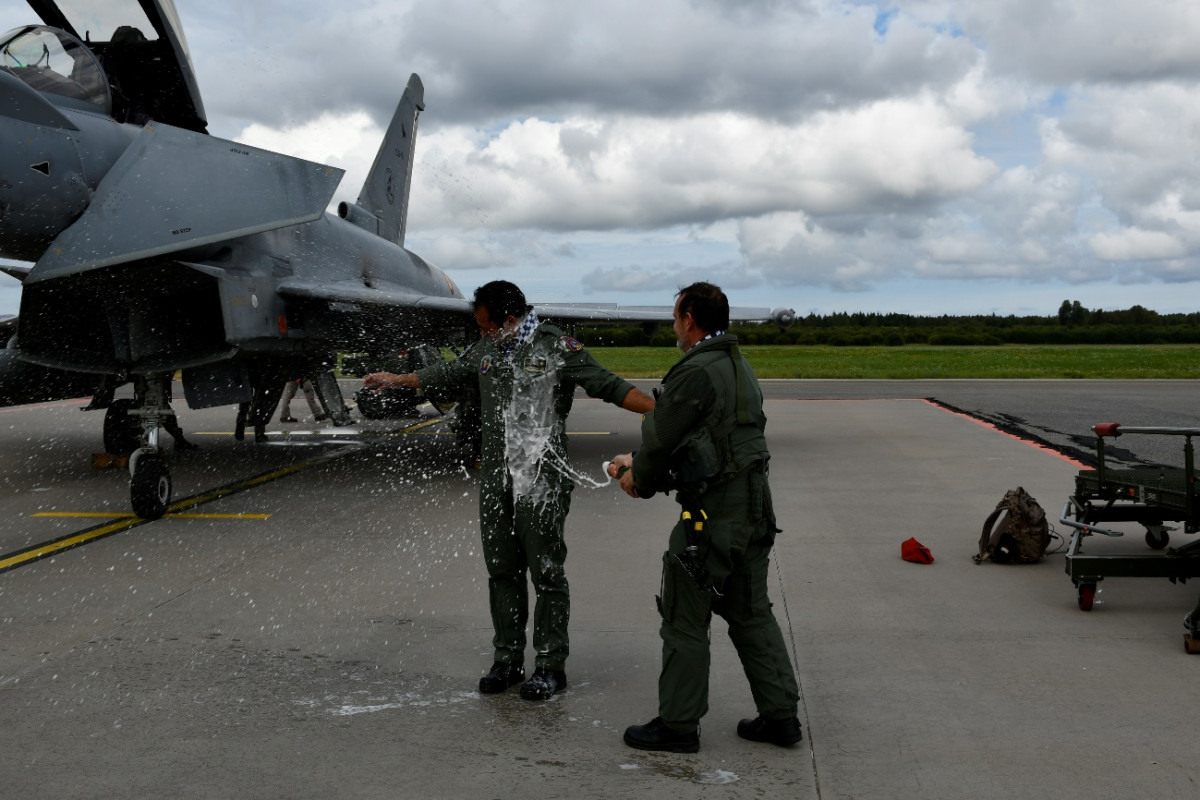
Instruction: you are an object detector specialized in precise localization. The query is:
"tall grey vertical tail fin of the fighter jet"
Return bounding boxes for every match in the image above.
[338,72,425,245]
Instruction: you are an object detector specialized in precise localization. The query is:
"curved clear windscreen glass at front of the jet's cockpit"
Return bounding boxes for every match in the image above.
[0,28,109,110]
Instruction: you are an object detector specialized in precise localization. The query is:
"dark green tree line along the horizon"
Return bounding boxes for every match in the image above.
[576,300,1200,347]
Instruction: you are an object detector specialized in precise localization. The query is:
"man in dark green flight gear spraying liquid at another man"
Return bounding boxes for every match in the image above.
[608,283,802,753]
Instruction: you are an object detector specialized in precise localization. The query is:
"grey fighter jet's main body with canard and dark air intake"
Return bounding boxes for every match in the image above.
[0,28,466,404]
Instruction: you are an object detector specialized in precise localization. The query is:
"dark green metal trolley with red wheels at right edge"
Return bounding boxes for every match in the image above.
[1060,422,1200,652]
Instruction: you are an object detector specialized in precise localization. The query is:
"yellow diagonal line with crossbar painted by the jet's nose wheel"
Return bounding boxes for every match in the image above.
[0,419,442,572]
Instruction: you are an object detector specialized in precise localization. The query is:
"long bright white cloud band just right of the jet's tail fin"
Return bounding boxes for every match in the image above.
[403,90,996,236]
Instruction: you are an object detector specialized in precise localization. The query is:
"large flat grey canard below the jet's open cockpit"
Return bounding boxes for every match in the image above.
[25,122,342,283]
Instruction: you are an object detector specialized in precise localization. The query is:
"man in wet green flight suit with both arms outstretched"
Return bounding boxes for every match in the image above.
[365,281,654,700]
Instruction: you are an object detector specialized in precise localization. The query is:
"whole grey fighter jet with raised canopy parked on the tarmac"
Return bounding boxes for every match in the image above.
[0,0,792,518]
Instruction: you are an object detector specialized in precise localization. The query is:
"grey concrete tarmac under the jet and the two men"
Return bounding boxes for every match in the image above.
[0,380,1200,800]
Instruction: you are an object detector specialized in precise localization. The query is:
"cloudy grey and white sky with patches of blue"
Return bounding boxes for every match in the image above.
[0,0,1200,314]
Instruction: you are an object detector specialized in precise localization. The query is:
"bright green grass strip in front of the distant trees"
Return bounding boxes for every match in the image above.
[589,344,1200,380]
